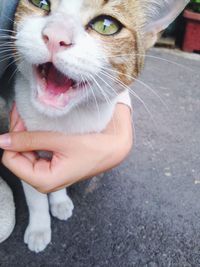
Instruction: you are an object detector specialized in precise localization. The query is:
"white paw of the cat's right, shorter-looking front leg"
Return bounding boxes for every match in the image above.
[50,196,74,221]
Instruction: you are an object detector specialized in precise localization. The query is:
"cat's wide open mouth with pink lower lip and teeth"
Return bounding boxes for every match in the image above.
[34,62,87,108]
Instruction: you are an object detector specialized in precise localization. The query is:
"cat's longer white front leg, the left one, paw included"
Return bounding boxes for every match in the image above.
[22,182,51,253]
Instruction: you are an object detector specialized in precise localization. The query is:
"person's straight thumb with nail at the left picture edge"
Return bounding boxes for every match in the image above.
[0,131,69,152]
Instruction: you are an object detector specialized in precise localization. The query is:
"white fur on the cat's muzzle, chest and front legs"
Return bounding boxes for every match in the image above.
[15,0,117,252]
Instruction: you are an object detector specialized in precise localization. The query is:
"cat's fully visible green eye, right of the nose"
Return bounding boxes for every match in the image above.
[90,16,122,35]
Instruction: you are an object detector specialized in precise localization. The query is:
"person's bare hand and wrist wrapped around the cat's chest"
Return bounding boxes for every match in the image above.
[0,103,133,193]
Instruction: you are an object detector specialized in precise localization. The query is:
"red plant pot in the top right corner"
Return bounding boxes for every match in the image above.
[183,0,200,52]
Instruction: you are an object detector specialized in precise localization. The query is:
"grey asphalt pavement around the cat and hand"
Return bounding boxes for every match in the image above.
[0,49,200,267]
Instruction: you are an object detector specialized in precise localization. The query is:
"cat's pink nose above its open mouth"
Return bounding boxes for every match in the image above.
[42,25,72,54]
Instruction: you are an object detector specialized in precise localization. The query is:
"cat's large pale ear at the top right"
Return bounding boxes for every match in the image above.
[144,0,189,48]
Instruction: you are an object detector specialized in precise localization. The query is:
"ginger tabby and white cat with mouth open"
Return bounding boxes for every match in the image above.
[8,0,187,253]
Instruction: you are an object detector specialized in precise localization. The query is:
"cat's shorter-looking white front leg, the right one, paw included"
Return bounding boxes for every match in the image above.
[49,189,74,221]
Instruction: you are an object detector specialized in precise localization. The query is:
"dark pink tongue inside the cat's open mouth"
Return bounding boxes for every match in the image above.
[45,64,74,95]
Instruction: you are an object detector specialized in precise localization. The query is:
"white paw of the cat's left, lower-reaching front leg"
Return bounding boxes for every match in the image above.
[24,226,51,253]
